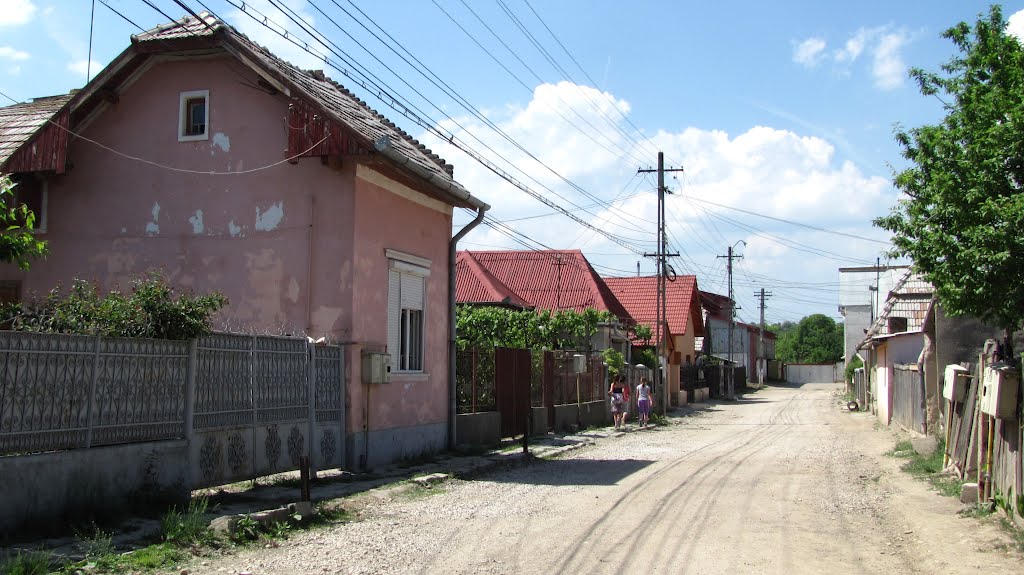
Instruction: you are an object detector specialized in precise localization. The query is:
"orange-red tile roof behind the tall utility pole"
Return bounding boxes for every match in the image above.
[604,275,703,345]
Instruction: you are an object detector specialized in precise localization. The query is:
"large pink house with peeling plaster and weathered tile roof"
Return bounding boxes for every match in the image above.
[0,13,487,468]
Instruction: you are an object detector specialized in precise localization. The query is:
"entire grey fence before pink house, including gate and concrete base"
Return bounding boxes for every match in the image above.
[0,331,345,533]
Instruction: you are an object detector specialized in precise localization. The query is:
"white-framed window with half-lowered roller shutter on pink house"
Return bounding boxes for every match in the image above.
[386,250,430,373]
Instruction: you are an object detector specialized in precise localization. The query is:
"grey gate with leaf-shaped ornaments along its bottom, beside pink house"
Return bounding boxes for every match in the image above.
[191,334,343,487]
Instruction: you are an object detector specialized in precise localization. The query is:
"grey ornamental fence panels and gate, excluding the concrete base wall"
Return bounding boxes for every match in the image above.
[0,331,345,482]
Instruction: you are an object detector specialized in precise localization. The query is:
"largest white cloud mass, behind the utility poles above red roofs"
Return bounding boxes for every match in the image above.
[423,83,895,291]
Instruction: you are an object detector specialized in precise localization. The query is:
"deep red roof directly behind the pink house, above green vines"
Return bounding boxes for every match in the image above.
[455,250,633,323]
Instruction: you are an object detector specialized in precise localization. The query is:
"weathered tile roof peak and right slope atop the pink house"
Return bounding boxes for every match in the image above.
[132,11,485,207]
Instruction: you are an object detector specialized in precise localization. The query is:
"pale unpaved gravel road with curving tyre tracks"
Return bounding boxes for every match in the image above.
[189,384,1024,575]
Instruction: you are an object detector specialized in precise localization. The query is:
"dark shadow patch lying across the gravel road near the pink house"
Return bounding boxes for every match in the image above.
[486,459,654,485]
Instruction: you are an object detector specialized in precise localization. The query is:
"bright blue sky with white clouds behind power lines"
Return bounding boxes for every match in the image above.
[0,0,1024,321]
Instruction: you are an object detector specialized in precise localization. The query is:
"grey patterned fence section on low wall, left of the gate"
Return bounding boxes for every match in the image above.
[0,331,188,455]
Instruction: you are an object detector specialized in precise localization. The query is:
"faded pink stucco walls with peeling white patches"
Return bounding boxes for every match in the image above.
[0,53,452,437]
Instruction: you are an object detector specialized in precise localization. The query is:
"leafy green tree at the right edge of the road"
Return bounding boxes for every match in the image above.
[874,6,1024,351]
